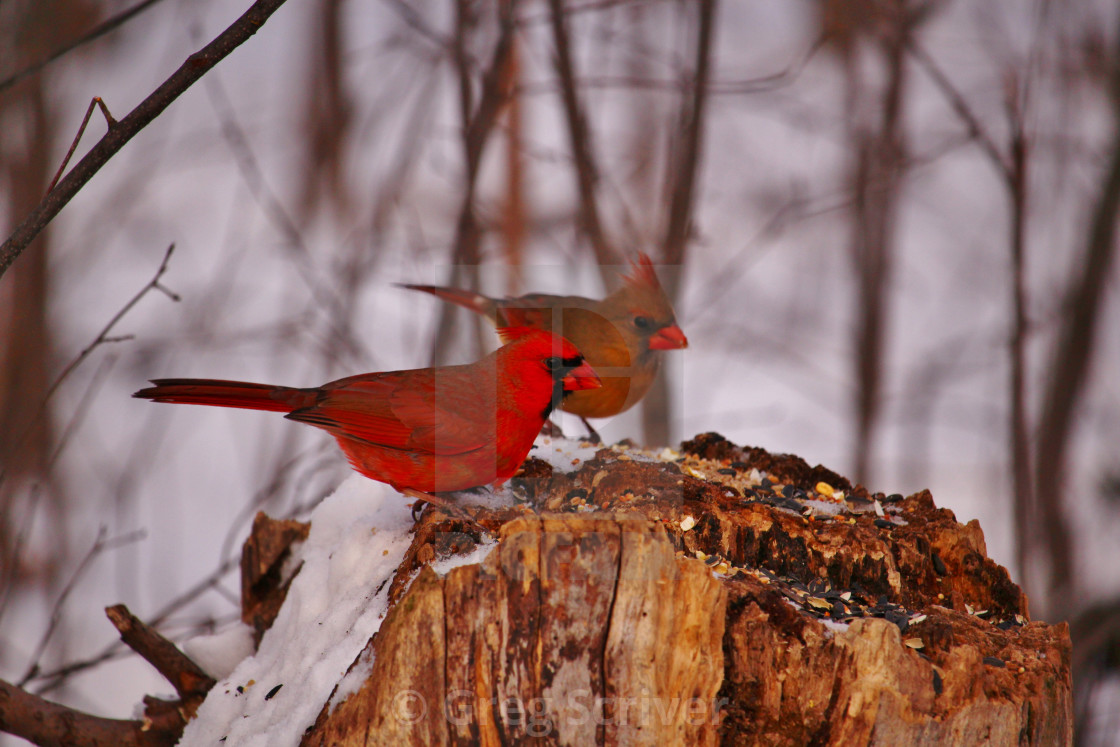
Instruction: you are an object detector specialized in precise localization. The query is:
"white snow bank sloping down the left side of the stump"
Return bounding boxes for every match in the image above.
[179,475,412,747]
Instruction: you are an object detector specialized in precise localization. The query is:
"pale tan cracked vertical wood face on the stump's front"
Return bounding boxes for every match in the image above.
[305,516,727,745]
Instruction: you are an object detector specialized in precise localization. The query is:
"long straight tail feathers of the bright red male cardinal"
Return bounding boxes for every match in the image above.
[132,379,317,412]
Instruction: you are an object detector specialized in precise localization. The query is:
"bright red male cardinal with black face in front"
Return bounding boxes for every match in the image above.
[132,327,600,505]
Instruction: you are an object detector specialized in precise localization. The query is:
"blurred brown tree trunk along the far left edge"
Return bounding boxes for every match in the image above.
[0,0,94,595]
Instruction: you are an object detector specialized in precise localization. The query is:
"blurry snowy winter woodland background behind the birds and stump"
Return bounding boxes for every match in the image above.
[0,0,1120,744]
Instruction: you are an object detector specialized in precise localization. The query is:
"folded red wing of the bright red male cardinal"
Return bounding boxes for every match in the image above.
[288,370,494,455]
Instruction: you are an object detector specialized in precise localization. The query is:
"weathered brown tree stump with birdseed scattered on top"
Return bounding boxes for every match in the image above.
[246,435,1072,745]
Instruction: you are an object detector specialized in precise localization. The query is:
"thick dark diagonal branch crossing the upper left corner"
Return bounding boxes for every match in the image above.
[0,0,293,283]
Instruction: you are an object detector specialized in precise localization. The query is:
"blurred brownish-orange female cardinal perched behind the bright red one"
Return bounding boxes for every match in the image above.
[403,254,689,433]
